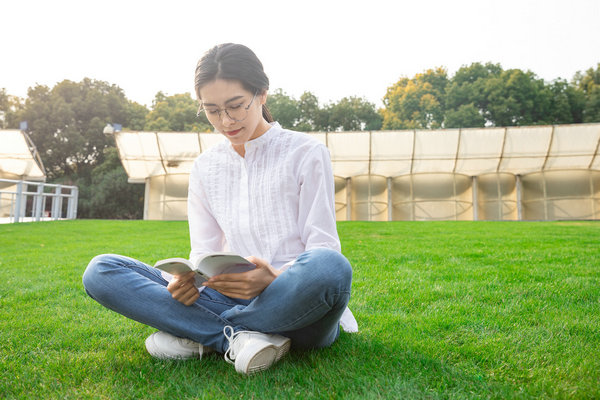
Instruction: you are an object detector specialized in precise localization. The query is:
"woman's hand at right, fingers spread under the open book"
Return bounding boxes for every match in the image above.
[203,256,281,299]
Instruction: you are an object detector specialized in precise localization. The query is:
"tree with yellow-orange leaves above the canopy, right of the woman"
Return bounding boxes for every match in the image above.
[382,68,448,129]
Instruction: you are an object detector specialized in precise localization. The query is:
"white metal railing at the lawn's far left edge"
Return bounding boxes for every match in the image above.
[0,179,79,222]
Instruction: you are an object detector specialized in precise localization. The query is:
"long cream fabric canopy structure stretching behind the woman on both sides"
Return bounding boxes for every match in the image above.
[115,124,600,221]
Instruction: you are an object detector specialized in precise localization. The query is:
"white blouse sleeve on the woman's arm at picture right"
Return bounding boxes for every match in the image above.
[298,145,341,251]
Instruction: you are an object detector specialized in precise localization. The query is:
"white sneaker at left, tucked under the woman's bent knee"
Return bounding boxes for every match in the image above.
[146,331,214,360]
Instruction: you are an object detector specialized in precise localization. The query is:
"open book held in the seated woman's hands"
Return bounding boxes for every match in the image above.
[154,253,255,286]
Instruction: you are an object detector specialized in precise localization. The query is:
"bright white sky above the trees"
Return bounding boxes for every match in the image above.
[0,0,600,106]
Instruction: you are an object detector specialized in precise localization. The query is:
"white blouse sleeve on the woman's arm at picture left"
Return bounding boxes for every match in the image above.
[188,159,225,263]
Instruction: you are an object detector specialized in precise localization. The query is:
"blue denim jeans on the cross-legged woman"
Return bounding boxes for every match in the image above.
[83,249,352,352]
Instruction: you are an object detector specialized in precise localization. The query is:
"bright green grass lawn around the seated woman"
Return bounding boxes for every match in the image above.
[0,220,600,399]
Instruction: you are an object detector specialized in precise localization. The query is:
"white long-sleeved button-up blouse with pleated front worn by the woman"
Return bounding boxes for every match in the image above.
[188,122,357,330]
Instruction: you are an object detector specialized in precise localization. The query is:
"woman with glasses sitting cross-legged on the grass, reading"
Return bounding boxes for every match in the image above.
[83,43,356,374]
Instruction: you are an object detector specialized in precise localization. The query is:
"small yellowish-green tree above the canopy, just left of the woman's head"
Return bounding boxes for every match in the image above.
[144,92,212,132]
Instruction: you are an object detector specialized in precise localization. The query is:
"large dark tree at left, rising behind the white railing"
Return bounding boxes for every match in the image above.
[16,78,141,179]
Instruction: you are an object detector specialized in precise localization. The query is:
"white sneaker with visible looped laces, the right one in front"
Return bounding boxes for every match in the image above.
[223,326,292,374]
